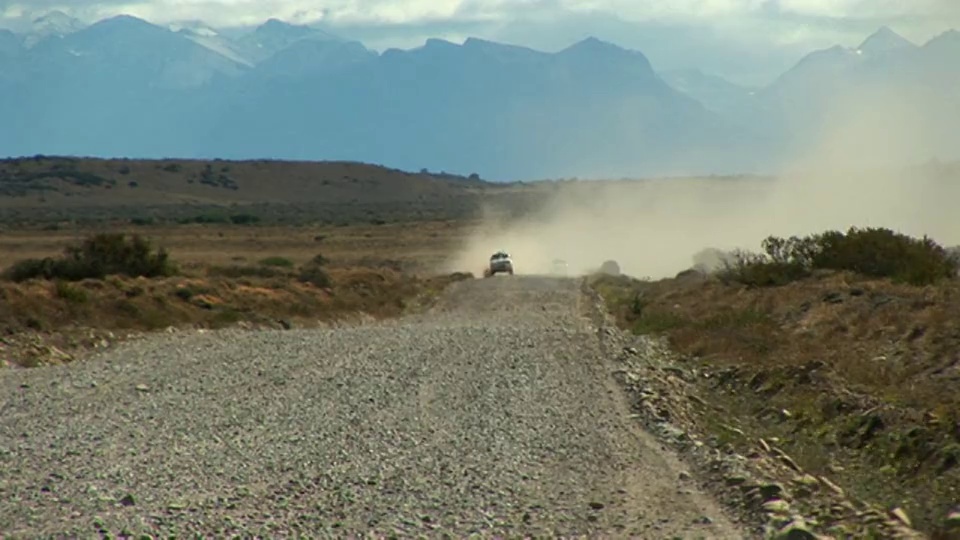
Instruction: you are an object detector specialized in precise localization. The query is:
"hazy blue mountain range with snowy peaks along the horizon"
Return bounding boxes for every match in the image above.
[0,12,960,180]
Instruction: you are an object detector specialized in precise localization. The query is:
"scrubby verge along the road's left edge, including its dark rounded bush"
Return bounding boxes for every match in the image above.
[0,225,472,367]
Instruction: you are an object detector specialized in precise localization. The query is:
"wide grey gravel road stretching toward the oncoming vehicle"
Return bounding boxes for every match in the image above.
[0,276,750,538]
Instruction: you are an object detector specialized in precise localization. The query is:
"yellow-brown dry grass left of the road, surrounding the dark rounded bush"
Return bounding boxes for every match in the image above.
[0,222,478,365]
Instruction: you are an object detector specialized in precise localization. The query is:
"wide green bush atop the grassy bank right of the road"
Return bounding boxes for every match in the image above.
[719,227,960,286]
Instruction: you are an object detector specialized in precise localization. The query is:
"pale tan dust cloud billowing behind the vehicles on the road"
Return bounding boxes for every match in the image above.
[448,83,960,279]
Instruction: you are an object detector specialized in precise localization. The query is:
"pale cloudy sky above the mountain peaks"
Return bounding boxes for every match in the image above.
[0,0,960,84]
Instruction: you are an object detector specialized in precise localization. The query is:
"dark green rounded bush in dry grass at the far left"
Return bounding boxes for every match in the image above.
[4,233,176,282]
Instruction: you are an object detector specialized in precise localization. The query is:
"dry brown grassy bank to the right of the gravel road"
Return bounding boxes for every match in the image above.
[594,272,960,532]
